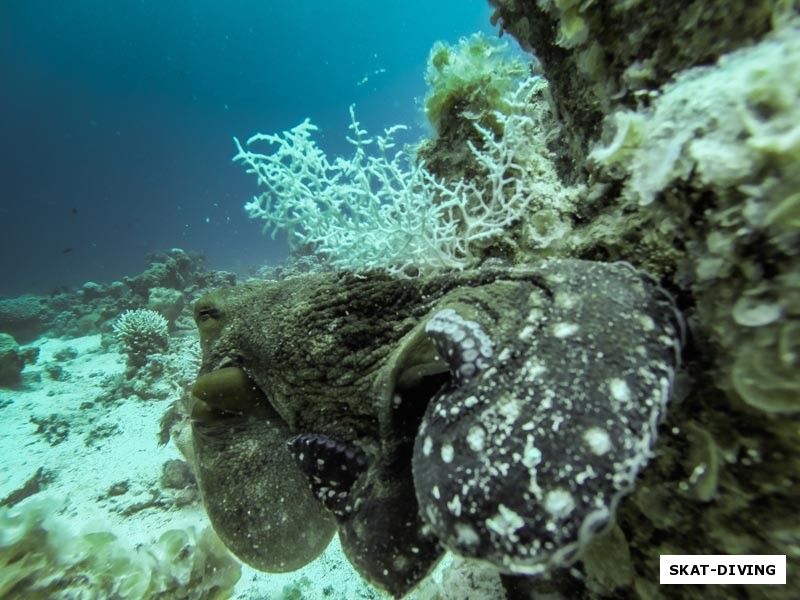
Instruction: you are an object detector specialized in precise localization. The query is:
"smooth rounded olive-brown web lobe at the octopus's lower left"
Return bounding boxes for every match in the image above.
[192,378,336,573]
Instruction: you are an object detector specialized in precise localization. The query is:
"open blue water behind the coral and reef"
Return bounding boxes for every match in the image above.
[0,0,495,297]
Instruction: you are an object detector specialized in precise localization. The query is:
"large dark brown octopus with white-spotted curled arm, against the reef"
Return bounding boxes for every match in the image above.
[191,260,684,597]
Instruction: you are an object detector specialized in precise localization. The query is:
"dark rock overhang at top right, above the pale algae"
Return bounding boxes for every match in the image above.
[490,0,794,170]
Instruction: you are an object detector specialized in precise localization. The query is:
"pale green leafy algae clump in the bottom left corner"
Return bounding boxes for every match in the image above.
[0,496,241,600]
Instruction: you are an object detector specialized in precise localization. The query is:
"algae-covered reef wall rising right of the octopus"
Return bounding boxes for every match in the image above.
[462,0,800,598]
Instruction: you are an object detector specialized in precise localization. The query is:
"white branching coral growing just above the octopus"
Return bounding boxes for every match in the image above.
[233,89,568,272]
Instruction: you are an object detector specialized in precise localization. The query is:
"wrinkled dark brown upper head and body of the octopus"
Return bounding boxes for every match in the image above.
[195,271,531,452]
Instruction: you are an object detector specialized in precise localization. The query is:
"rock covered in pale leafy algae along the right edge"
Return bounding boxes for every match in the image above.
[591,23,800,413]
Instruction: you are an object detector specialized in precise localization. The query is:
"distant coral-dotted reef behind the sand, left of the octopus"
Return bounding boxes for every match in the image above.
[0,248,228,406]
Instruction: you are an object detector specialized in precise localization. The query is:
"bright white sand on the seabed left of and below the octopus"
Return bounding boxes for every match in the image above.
[0,335,502,600]
